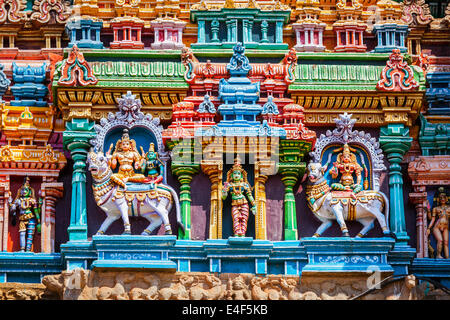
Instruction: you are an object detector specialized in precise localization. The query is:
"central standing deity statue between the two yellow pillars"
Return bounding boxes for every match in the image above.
[222,157,256,237]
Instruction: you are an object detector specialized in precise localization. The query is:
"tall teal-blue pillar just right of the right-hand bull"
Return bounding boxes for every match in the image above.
[380,124,412,242]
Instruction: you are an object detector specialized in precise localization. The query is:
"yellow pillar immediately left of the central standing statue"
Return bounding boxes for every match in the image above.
[201,161,223,239]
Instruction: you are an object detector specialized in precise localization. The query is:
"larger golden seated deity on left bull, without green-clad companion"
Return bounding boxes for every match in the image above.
[107,129,146,190]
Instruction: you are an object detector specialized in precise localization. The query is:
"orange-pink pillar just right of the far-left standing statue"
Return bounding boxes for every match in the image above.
[41,177,64,253]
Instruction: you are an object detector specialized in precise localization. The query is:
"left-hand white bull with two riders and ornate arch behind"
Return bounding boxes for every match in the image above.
[88,92,184,235]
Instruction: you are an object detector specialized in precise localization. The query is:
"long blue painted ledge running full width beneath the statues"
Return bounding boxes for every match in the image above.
[0,235,450,283]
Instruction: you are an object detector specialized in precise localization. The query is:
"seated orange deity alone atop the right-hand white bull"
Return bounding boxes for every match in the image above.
[330,144,367,199]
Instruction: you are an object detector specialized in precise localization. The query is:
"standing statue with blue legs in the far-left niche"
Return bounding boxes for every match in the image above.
[10,177,42,252]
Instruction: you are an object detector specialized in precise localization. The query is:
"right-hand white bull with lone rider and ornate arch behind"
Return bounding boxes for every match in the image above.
[306,113,392,237]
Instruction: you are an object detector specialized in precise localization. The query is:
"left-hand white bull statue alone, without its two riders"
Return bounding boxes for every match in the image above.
[88,151,184,235]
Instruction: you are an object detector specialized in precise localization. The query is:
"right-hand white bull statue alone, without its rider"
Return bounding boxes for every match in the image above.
[306,162,394,237]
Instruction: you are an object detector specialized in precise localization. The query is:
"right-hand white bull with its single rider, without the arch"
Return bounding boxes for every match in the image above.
[306,143,393,237]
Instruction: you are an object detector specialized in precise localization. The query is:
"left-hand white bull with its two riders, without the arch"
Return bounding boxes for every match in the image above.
[88,129,184,235]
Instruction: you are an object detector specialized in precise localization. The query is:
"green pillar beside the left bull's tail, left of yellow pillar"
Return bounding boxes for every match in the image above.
[172,163,199,240]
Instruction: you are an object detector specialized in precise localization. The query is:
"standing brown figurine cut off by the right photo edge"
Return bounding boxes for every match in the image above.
[427,187,450,259]
